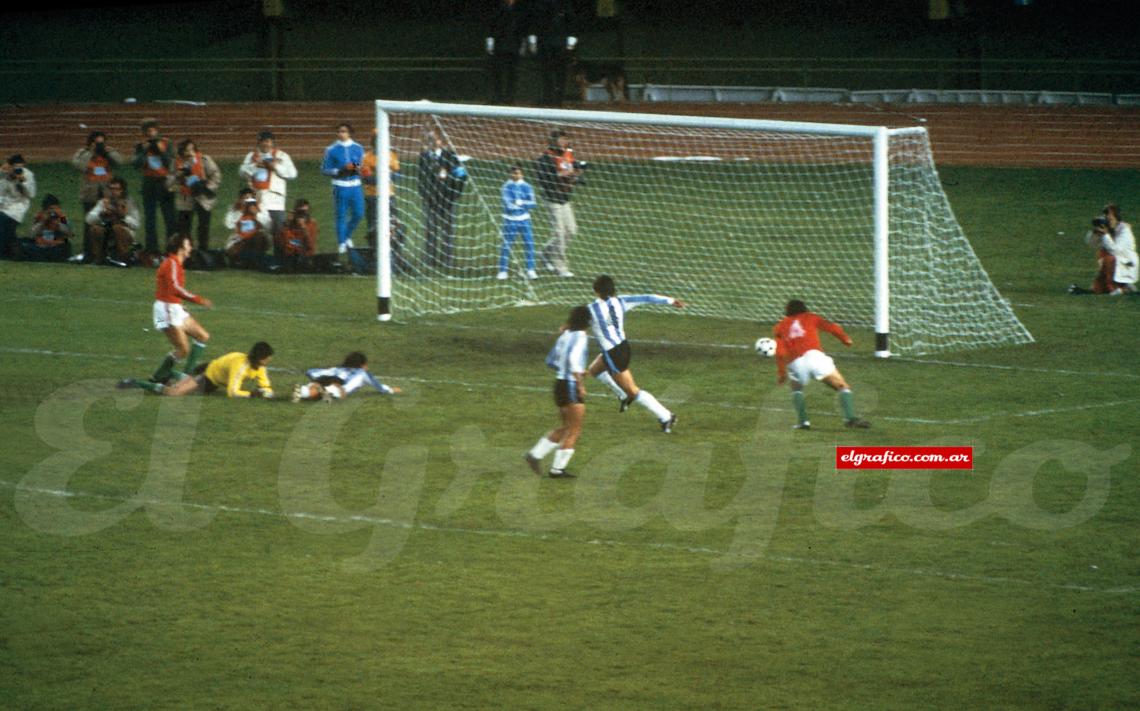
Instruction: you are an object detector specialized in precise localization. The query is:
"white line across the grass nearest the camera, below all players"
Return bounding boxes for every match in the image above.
[0,480,1138,595]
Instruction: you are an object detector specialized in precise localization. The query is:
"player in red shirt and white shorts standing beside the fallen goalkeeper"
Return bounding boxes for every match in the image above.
[150,235,213,383]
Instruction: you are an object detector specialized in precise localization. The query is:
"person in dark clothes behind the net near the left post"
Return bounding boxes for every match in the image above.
[416,128,467,269]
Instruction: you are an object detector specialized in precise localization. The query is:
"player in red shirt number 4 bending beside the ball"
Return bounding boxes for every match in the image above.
[772,299,871,430]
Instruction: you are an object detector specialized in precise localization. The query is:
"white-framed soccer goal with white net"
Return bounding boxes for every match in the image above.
[376,101,1033,357]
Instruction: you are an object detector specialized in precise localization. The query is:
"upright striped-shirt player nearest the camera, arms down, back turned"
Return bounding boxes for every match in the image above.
[523,307,589,479]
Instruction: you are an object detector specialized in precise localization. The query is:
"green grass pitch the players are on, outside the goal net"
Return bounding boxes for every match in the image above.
[0,166,1140,709]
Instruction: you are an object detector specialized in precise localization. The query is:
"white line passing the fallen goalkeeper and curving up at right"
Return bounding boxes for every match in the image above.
[0,346,1140,425]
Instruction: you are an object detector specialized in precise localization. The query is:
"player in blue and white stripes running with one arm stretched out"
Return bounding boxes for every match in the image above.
[589,275,685,434]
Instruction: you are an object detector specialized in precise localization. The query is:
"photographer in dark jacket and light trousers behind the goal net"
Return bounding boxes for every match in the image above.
[535,130,587,277]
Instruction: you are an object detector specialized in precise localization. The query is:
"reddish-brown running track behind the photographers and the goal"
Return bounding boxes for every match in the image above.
[0,101,1140,169]
